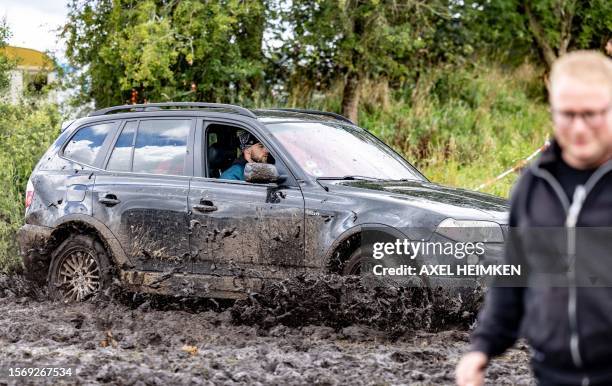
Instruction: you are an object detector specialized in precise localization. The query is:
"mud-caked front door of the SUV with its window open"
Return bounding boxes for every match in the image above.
[189,121,304,277]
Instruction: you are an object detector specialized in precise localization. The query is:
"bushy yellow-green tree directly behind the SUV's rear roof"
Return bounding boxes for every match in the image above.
[62,0,265,106]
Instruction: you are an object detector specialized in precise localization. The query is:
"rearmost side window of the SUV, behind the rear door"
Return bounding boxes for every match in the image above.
[64,122,114,165]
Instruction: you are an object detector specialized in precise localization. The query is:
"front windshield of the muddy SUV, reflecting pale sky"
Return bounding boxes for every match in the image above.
[267,122,423,180]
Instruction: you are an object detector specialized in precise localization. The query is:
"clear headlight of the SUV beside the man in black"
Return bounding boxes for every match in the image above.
[436,218,504,243]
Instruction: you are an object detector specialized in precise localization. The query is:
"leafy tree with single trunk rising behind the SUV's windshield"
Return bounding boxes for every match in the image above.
[268,0,464,121]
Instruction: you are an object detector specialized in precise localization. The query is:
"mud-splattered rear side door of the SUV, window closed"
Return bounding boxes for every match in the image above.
[93,118,195,272]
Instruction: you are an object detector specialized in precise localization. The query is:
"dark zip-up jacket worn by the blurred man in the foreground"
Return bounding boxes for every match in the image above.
[472,142,612,384]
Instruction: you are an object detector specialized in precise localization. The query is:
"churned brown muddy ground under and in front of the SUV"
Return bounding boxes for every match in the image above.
[0,276,533,385]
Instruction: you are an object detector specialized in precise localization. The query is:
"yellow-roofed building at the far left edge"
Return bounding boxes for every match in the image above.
[0,46,57,103]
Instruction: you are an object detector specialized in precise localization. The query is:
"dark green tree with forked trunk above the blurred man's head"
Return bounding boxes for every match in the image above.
[458,0,612,69]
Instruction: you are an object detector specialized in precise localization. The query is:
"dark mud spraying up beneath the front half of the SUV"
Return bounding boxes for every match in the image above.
[230,275,483,338]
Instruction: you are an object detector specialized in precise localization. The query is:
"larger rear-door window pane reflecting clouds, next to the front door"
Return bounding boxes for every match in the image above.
[133,119,191,175]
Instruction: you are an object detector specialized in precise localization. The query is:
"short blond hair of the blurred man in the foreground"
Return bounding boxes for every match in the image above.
[550,51,612,96]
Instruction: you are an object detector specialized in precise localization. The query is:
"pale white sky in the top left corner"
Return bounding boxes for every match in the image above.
[0,0,68,61]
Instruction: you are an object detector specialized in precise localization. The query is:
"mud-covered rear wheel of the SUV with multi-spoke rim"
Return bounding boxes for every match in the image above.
[48,235,112,303]
